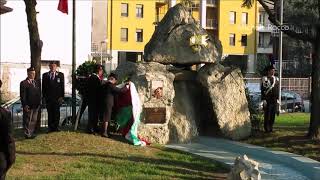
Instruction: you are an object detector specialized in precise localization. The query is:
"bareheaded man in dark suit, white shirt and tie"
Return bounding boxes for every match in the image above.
[42,62,64,132]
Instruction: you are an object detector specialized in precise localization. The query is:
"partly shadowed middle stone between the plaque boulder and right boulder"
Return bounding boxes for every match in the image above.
[169,71,201,143]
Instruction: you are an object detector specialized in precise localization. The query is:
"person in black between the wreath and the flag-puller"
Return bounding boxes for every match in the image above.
[87,65,103,134]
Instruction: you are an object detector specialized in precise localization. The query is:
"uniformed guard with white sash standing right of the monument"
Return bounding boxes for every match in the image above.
[261,65,279,133]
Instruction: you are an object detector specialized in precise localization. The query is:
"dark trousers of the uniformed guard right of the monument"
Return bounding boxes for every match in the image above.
[264,102,277,132]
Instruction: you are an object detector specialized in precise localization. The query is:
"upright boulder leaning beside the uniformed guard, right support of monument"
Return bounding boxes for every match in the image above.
[198,64,251,140]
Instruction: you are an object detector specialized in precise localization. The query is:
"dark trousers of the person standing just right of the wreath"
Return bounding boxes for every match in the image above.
[87,102,99,133]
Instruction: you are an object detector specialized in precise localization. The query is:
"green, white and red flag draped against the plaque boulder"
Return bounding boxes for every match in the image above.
[115,83,150,146]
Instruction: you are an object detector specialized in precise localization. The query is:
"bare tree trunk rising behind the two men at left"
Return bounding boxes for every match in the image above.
[24,0,43,80]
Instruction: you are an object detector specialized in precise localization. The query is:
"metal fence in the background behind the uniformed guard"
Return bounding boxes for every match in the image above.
[244,78,311,99]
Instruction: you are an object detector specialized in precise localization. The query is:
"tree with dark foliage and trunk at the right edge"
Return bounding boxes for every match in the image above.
[243,0,320,140]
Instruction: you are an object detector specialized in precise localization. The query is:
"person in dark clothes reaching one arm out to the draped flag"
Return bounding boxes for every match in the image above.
[101,73,129,137]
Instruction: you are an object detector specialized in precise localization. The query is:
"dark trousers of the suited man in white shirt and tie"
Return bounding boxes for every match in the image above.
[47,102,60,131]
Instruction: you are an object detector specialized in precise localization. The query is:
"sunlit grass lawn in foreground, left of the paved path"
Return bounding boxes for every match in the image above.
[7,132,228,180]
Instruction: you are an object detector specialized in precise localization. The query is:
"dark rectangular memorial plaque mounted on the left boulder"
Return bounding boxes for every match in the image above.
[144,108,166,124]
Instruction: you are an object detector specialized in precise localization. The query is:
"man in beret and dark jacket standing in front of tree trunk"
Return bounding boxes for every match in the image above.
[20,67,41,138]
